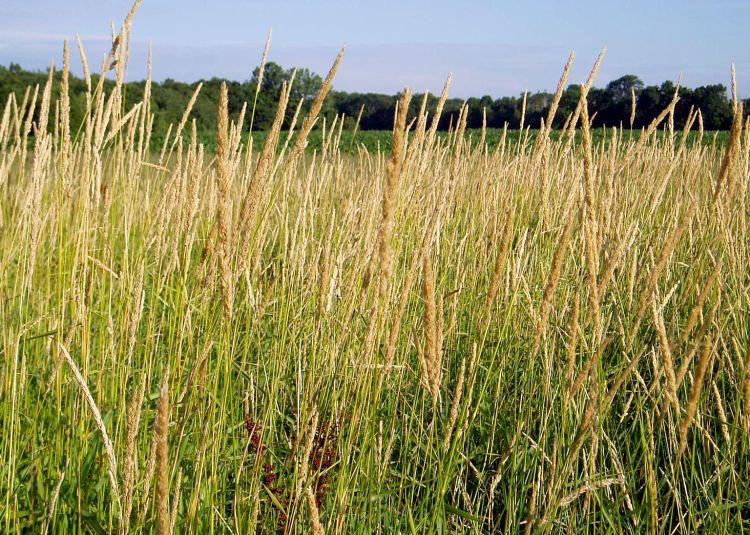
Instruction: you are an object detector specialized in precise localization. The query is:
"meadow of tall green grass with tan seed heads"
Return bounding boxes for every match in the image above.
[0,9,750,534]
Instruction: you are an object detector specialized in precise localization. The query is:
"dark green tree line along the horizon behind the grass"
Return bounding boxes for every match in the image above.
[0,62,750,142]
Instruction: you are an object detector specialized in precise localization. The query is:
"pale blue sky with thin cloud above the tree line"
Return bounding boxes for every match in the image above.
[0,0,750,98]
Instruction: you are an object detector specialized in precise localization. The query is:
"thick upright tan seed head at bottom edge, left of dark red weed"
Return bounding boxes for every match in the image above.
[153,367,172,535]
